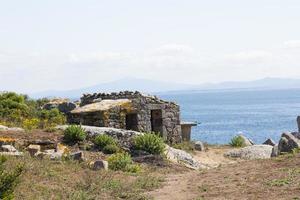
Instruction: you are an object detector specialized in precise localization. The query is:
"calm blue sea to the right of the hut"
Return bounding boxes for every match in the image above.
[159,89,300,144]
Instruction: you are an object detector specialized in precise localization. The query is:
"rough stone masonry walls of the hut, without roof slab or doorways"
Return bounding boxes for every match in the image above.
[70,91,182,143]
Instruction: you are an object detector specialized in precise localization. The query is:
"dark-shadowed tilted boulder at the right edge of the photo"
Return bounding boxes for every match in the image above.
[278,133,300,154]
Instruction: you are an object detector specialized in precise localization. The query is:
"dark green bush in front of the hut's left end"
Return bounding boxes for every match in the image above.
[63,125,86,143]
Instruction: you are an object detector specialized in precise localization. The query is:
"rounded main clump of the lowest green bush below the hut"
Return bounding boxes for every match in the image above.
[108,153,132,171]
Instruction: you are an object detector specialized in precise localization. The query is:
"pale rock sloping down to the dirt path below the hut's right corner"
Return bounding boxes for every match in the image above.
[165,146,208,170]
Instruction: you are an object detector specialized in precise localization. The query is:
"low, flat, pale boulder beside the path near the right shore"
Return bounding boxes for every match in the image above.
[225,145,273,160]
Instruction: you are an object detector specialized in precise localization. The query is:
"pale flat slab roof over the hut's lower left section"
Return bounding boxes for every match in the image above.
[71,99,131,113]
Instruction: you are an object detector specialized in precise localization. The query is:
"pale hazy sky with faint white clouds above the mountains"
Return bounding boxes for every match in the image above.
[0,0,300,92]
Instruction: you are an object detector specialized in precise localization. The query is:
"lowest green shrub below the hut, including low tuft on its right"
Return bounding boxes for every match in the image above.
[108,153,140,173]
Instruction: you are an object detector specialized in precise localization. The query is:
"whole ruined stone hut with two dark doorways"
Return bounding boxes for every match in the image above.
[68,91,182,143]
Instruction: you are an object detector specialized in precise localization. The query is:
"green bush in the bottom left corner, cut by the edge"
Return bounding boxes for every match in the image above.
[0,156,23,200]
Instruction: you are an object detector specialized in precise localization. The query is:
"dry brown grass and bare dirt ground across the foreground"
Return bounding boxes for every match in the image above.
[0,131,300,200]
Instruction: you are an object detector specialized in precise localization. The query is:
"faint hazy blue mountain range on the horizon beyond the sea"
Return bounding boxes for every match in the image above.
[30,78,300,99]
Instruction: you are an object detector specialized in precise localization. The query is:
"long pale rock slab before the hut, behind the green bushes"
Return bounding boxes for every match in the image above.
[57,125,143,150]
